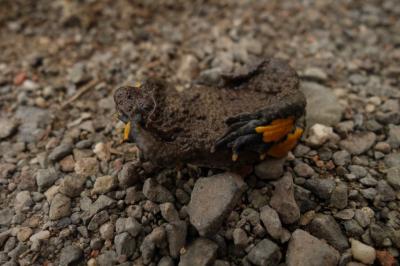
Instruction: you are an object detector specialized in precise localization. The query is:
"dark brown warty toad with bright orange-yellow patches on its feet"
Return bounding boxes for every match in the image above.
[114,59,306,169]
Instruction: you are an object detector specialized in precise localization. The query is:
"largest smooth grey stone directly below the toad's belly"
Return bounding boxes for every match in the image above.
[188,172,245,236]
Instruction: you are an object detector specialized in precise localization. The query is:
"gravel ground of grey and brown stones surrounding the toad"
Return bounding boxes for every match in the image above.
[0,0,400,266]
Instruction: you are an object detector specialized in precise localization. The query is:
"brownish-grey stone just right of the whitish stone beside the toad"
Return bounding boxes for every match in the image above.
[339,132,376,155]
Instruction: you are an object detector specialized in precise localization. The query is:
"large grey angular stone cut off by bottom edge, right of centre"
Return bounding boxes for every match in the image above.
[286,229,340,266]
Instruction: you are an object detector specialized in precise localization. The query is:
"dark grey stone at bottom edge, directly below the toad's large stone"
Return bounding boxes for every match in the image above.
[178,238,218,266]
